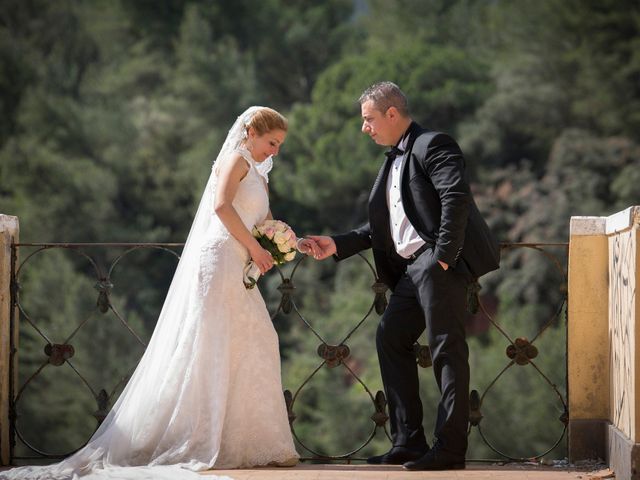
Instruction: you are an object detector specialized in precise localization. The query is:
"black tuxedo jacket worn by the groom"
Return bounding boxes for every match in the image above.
[333,122,500,289]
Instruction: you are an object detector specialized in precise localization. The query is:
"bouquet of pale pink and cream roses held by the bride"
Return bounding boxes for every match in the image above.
[243,220,297,289]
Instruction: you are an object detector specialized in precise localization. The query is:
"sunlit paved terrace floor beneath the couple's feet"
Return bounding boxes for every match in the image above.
[202,464,615,480]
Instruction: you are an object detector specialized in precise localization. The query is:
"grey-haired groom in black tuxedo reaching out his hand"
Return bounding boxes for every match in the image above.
[309,82,499,470]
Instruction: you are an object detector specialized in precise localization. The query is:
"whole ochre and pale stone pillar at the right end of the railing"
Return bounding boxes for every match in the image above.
[567,206,640,480]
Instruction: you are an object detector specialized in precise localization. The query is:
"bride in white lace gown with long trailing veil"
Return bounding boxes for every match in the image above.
[0,107,314,480]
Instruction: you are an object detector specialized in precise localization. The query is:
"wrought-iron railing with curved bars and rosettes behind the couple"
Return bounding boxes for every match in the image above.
[10,243,568,461]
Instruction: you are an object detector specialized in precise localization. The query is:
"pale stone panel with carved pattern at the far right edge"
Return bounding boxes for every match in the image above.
[607,207,640,480]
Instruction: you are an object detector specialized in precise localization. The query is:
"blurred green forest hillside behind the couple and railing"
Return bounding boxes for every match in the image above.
[0,0,640,459]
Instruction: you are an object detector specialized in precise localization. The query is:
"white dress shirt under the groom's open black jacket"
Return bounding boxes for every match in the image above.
[387,135,425,258]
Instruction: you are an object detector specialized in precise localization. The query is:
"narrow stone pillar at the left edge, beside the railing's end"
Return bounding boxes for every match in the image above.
[0,214,19,465]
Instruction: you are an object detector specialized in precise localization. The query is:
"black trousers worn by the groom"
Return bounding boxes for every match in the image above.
[376,250,471,455]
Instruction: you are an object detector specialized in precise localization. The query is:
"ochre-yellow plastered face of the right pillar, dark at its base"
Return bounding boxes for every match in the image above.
[567,217,610,462]
